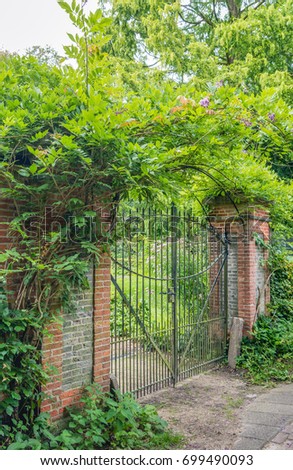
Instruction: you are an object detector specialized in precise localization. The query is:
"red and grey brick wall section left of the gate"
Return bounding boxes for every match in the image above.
[41,206,111,420]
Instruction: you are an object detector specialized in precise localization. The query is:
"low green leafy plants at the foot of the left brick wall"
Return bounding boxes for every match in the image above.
[7,386,180,450]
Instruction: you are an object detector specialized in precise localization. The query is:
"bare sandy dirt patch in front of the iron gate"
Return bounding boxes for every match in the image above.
[139,367,267,450]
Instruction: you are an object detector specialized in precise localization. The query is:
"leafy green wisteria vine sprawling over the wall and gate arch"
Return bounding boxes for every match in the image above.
[0,1,292,308]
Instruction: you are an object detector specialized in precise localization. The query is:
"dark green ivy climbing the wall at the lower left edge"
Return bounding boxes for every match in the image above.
[0,282,47,445]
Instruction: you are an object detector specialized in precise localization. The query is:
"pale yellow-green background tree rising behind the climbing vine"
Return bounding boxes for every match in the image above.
[100,0,292,91]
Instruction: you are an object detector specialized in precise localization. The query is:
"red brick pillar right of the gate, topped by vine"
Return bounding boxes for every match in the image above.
[209,197,270,335]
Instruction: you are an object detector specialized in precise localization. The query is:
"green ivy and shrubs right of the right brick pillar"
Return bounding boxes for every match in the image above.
[238,252,293,383]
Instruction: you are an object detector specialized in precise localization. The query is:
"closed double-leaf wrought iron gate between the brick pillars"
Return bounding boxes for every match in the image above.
[111,207,227,396]
